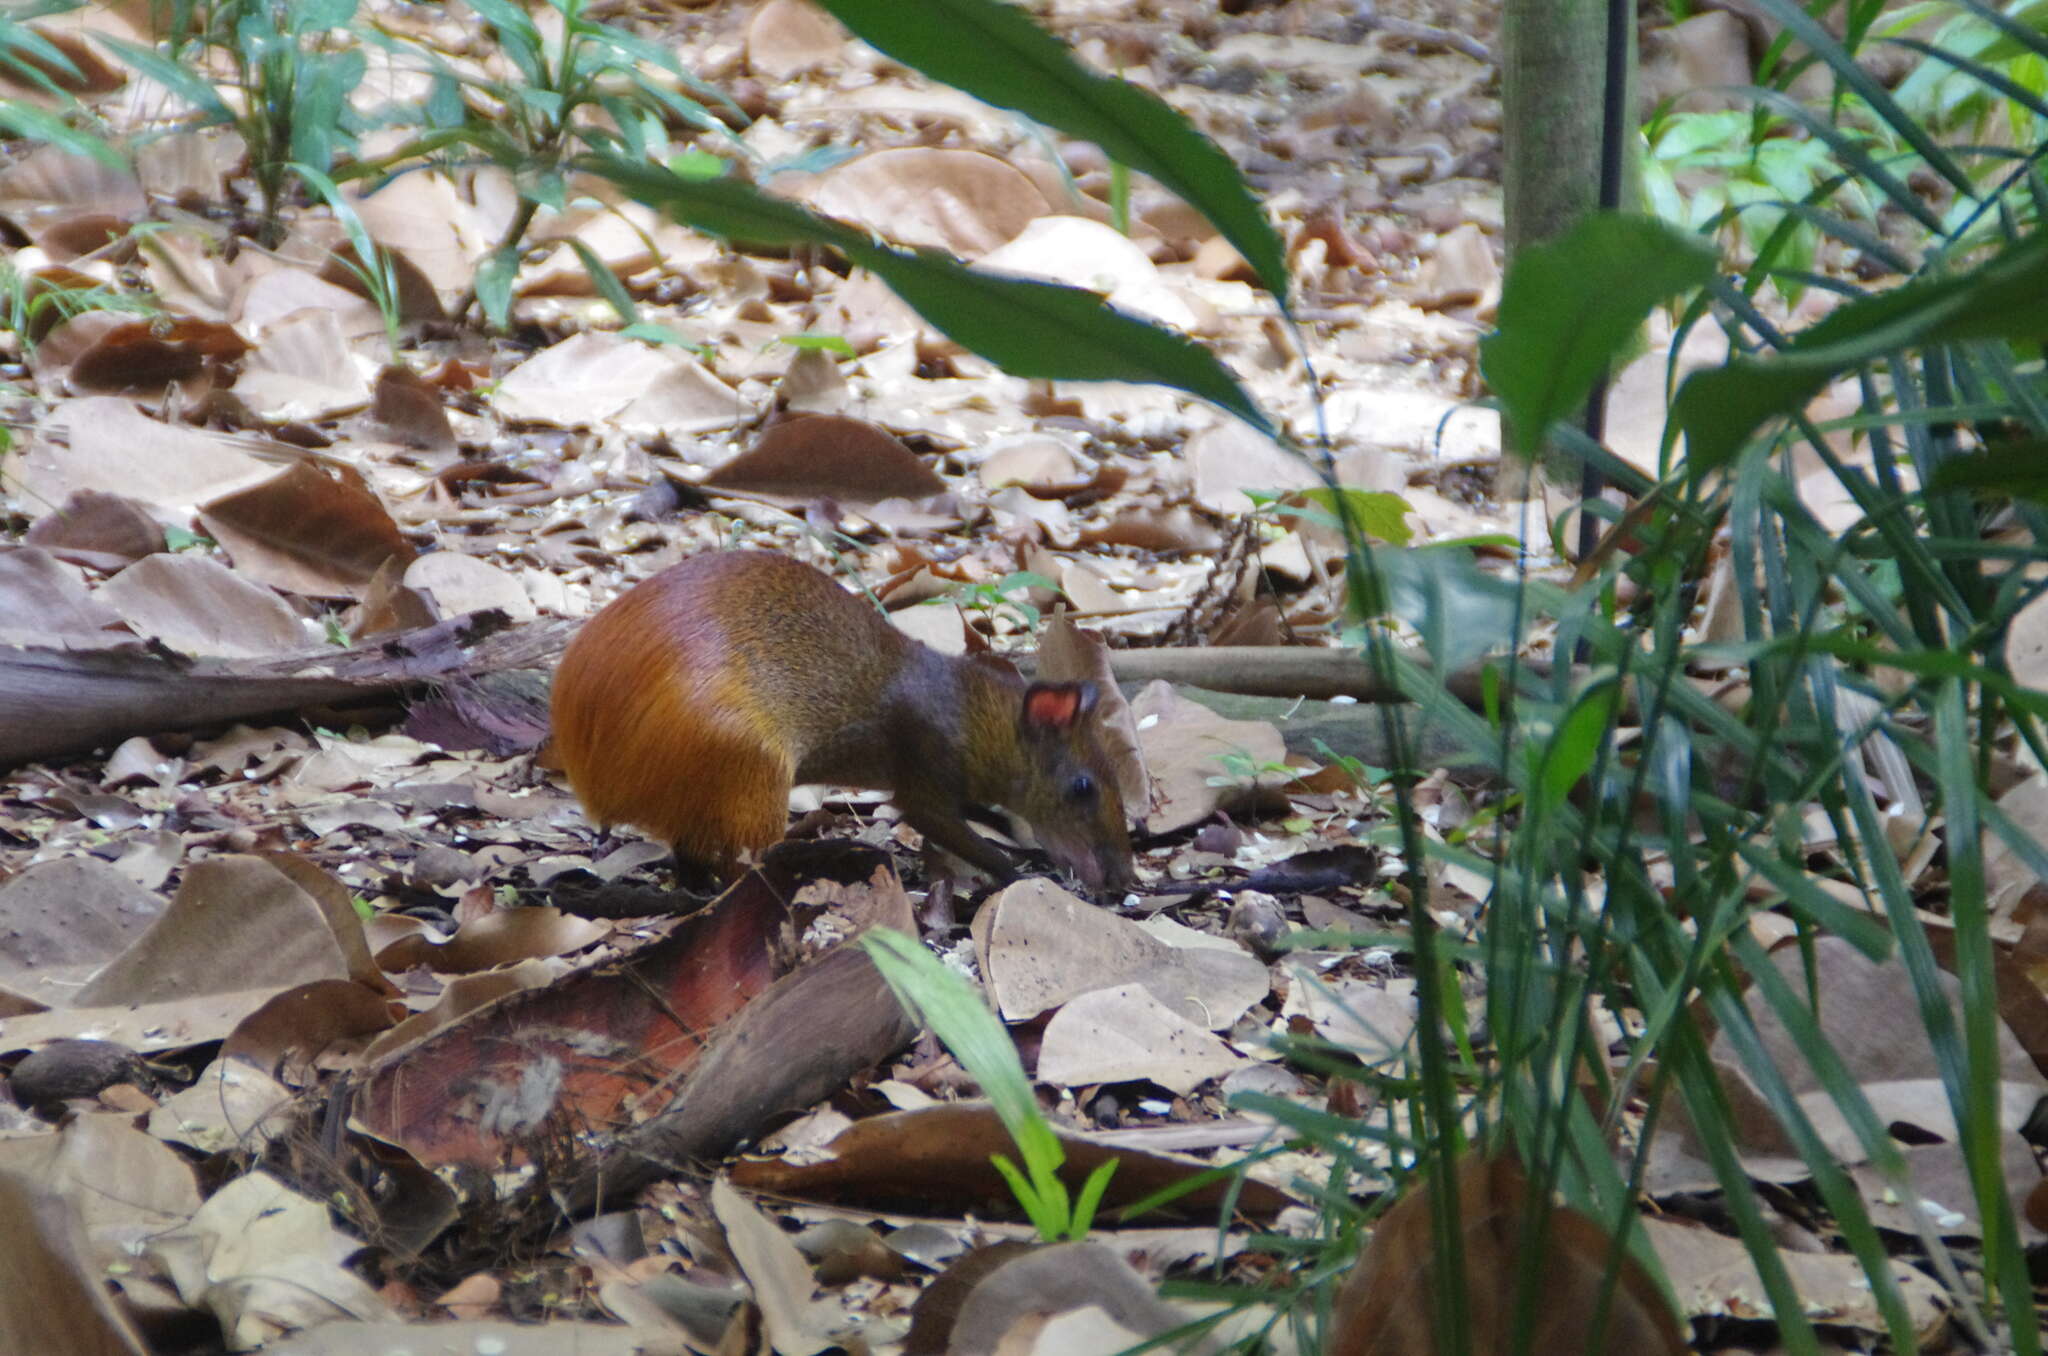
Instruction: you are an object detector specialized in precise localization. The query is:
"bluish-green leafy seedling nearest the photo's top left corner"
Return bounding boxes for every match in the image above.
[100,0,369,246]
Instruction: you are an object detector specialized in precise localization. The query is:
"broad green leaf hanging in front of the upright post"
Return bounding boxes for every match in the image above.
[1479,213,1714,457]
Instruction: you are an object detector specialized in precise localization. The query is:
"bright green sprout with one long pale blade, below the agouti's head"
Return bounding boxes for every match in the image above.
[860,928,1116,1243]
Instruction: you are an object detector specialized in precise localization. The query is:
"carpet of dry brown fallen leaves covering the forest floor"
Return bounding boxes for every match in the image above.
[0,0,2023,1352]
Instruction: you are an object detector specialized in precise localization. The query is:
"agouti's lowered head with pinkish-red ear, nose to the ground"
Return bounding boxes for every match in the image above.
[1010,682,1133,891]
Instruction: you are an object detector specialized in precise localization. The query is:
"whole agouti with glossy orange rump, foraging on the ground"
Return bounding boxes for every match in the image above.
[553,551,1130,889]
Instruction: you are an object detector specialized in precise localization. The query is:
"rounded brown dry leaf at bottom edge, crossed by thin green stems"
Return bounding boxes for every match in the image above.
[1327,1151,1688,1356]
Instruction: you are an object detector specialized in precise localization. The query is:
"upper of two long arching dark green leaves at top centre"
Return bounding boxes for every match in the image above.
[821,0,1288,309]
